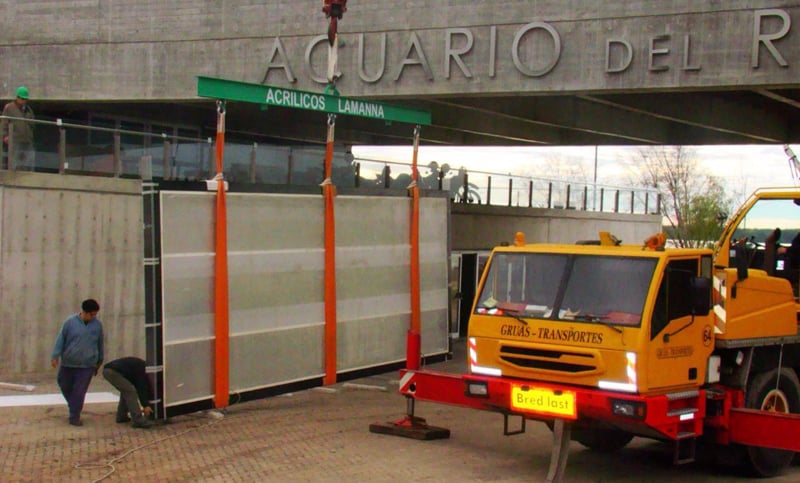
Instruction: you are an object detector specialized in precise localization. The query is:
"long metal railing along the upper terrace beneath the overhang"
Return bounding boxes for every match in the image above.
[0,116,661,214]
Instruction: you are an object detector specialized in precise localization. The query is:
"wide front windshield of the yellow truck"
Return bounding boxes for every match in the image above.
[475,253,657,327]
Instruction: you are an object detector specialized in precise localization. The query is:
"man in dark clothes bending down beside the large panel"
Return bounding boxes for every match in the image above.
[103,357,153,428]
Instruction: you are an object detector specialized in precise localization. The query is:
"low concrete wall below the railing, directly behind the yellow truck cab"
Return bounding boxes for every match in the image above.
[450,203,661,251]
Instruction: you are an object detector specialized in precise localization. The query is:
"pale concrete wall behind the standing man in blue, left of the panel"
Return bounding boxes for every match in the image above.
[0,171,144,376]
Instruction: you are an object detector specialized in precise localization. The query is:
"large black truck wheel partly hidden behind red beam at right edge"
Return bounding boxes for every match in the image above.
[745,368,800,477]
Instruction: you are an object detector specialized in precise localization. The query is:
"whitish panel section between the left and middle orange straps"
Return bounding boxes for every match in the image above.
[228,193,325,392]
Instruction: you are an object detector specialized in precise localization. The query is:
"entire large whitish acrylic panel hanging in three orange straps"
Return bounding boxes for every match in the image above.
[161,191,448,407]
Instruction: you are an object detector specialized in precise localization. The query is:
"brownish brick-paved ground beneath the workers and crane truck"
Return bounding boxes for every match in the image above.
[0,342,800,482]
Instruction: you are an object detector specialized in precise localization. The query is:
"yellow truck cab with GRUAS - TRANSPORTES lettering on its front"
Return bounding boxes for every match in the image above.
[469,233,714,395]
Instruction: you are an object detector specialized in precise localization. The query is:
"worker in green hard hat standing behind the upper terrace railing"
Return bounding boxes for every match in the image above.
[0,86,36,170]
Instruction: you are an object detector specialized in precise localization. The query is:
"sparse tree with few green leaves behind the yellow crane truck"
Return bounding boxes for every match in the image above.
[631,146,732,247]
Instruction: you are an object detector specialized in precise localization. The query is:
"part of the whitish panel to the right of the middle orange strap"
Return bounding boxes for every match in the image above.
[336,196,448,371]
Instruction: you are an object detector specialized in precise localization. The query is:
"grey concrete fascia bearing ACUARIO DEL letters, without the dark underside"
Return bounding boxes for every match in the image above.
[0,0,800,101]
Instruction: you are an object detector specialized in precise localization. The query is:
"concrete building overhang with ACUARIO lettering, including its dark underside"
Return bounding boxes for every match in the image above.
[0,0,800,145]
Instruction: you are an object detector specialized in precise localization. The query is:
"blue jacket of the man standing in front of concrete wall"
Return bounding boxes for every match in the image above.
[50,314,103,367]
